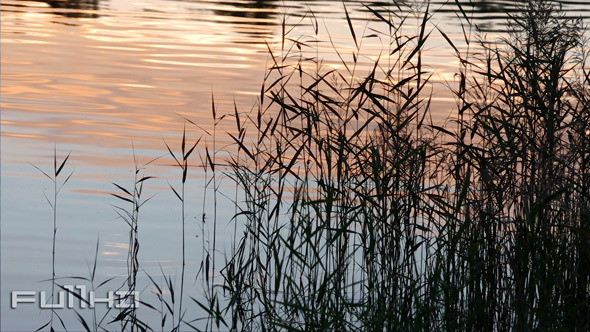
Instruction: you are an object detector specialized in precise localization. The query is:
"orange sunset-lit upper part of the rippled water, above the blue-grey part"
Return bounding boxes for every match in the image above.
[1,0,588,172]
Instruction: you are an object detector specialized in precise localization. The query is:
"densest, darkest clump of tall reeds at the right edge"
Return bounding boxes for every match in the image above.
[443,1,590,331]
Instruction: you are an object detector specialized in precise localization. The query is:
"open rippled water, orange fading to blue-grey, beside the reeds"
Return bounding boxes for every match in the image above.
[1,0,590,331]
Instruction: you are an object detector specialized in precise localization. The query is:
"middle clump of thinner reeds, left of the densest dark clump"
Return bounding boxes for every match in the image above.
[223,1,448,331]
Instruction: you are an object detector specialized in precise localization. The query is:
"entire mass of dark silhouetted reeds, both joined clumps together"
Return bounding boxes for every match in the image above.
[33,1,590,331]
